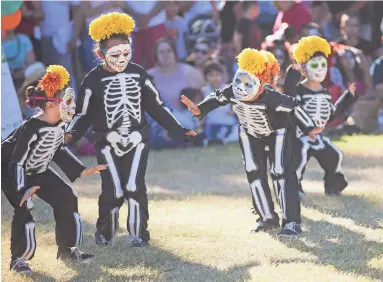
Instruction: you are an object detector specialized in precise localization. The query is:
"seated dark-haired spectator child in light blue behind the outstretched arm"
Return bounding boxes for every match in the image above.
[202,61,238,144]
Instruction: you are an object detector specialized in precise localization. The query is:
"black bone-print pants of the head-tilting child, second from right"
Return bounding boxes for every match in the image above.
[239,126,301,226]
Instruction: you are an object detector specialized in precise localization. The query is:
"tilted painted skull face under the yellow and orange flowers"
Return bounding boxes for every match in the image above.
[233,69,261,101]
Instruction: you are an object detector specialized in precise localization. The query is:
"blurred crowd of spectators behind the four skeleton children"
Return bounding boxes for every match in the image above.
[2,0,383,154]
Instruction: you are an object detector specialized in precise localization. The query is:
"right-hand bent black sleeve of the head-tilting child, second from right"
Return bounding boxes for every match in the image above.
[266,88,316,134]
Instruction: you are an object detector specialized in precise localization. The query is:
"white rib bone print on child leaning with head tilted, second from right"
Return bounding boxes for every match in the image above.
[232,99,273,137]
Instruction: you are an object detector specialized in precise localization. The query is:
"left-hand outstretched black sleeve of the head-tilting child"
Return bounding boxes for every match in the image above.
[197,84,233,119]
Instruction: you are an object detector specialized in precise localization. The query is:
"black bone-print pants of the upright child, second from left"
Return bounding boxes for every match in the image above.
[96,143,150,241]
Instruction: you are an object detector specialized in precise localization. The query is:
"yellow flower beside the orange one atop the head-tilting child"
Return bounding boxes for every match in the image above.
[237,48,268,82]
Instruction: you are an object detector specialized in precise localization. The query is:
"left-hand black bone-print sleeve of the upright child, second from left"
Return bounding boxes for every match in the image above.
[67,76,96,143]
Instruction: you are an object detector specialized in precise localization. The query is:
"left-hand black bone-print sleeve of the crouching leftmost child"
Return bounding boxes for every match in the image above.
[8,121,38,192]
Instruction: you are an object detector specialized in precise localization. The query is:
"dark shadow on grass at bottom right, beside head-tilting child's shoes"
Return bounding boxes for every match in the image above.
[276,218,383,281]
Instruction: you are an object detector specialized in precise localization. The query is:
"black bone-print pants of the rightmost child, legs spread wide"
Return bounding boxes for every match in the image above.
[297,136,348,193]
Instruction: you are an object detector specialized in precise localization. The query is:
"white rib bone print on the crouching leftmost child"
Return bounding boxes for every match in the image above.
[25,123,65,174]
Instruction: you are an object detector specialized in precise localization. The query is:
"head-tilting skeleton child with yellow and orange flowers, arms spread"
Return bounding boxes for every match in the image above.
[182,48,321,236]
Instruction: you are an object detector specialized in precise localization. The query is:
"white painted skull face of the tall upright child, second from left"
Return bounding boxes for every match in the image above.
[105,44,132,72]
